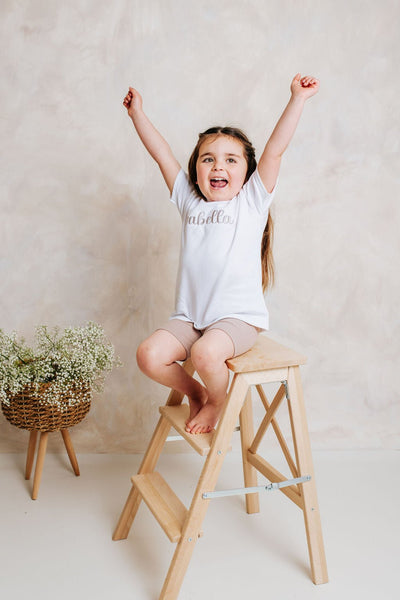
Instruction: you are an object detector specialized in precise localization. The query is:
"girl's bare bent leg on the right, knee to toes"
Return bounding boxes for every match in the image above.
[186,329,234,433]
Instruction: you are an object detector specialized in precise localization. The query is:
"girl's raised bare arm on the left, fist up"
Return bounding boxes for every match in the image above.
[123,87,181,193]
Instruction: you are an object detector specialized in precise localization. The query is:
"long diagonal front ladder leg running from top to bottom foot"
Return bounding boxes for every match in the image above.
[159,374,249,600]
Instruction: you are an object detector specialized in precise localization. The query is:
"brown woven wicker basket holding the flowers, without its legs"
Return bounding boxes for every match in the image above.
[1,383,91,432]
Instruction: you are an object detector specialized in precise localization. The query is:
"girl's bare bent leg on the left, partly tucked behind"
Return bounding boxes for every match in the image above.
[136,329,208,420]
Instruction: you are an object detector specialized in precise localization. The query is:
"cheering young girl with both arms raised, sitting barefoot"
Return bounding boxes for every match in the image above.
[123,73,319,434]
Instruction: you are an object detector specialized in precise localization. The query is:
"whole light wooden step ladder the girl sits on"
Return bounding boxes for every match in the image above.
[113,335,328,600]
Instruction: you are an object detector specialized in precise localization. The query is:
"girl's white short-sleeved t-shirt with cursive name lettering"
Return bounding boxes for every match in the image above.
[170,170,276,329]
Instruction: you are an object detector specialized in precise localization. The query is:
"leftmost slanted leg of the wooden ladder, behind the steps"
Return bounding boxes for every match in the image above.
[112,359,194,541]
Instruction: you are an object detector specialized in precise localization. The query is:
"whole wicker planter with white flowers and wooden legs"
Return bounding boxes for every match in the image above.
[0,321,121,500]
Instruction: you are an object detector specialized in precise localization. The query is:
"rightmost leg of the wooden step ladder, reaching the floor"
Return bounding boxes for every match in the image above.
[288,367,328,584]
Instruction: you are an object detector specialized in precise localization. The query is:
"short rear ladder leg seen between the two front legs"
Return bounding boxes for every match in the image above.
[239,389,260,514]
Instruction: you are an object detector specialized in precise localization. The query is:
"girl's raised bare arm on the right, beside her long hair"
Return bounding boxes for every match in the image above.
[258,73,319,192]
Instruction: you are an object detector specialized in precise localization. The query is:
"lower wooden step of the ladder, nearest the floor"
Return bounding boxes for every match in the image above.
[131,471,188,542]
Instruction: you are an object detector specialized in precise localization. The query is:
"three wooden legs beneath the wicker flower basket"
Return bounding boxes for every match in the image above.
[25,429,80,500]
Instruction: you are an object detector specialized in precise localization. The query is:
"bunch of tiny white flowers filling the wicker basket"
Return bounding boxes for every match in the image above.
[0,321,121,411]
